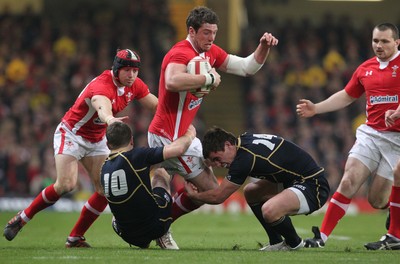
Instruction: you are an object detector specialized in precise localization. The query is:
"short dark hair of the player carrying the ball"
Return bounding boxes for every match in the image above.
[186,6,219,32]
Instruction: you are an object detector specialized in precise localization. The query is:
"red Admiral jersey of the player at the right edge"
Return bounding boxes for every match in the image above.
[345,52,400,132]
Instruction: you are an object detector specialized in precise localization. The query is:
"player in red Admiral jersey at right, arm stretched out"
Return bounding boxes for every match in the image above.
[297,23,400,247]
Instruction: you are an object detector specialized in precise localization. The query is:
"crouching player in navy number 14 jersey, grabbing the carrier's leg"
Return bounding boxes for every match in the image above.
[186,127,329,251]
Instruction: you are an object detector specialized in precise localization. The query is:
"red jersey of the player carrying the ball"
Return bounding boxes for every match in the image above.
[149,40,228,141]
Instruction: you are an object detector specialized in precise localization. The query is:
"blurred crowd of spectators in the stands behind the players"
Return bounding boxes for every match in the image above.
[0,1,397,200]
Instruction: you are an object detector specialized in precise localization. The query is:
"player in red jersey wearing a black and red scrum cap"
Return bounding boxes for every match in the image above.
[4,49,158,247]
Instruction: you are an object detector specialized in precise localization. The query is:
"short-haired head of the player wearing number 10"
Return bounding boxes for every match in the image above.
[106,122,132,150]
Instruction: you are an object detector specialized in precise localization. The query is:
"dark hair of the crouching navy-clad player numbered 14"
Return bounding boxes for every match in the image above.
[201,126,237,159]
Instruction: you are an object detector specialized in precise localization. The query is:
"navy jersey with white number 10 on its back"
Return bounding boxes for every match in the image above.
[101,147,164,224]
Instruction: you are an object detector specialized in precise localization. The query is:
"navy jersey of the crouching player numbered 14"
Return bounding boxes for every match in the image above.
[227,133,324,188]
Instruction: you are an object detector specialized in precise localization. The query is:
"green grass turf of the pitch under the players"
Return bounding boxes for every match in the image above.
[0,211,400,264]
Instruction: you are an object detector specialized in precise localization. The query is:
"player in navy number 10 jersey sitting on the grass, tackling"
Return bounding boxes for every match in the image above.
[101,122,196,248]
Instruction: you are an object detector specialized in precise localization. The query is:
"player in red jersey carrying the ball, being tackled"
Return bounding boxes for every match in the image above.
[148,7,278,249]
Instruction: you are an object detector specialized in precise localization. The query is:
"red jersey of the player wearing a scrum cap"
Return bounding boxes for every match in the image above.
[62,70,150,142]
